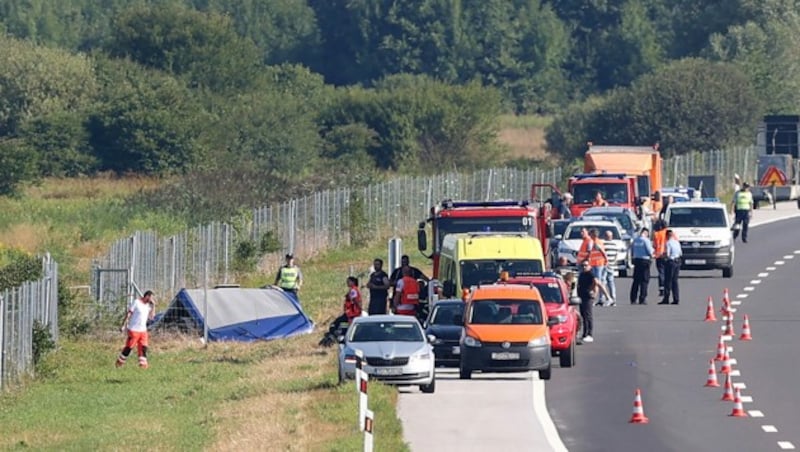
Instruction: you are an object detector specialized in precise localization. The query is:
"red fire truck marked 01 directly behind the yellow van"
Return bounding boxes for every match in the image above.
[417,199,547,278]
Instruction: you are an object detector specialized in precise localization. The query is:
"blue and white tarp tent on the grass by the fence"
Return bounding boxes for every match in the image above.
[151,287,314,342]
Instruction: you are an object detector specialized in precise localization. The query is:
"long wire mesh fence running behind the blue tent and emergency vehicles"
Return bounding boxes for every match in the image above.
[92,147,757,312]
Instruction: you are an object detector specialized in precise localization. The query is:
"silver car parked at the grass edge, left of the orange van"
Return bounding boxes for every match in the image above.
[339,315,436,393]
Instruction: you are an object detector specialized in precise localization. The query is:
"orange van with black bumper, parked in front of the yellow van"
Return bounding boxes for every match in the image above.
[459,283,557,380]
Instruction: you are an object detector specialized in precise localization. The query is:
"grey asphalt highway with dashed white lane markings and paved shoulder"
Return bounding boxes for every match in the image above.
[398,203,800,452]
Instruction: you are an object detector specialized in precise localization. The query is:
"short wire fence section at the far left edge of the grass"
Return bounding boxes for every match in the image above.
[0,254,58,389]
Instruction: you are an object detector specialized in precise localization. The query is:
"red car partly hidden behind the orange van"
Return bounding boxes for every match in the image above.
[506,272,582,367]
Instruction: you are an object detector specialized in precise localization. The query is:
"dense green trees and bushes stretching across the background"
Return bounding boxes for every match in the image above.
[0,0,800,215]
